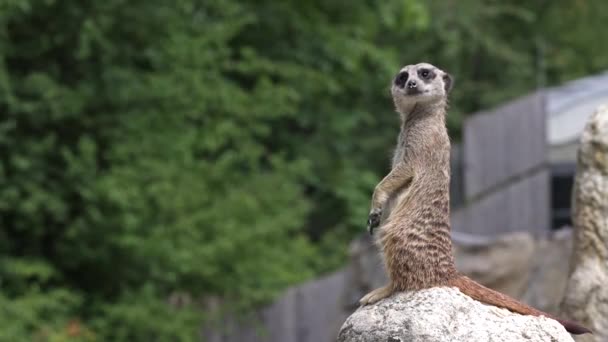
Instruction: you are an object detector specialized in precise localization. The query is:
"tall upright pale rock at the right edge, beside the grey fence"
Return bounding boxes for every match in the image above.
[562,106,608,341]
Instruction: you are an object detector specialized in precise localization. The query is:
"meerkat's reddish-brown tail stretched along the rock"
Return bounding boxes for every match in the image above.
[449,276,592,335]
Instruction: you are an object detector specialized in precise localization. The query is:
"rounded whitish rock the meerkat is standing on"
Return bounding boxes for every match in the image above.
[338,287,573,342]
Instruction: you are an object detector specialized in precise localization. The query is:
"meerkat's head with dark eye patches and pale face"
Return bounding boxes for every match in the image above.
[391,63,453,112]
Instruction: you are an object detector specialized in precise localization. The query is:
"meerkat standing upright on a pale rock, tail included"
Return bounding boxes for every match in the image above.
[360,63,591,334]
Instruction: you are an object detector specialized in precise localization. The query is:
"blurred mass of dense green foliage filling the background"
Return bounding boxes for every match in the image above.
[0,0,608,341]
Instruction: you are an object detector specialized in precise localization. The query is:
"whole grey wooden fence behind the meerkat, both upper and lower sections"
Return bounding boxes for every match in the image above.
[452,92,551,236]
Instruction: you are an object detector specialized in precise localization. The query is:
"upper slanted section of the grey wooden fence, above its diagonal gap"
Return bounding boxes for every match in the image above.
[463,92,548,199]
